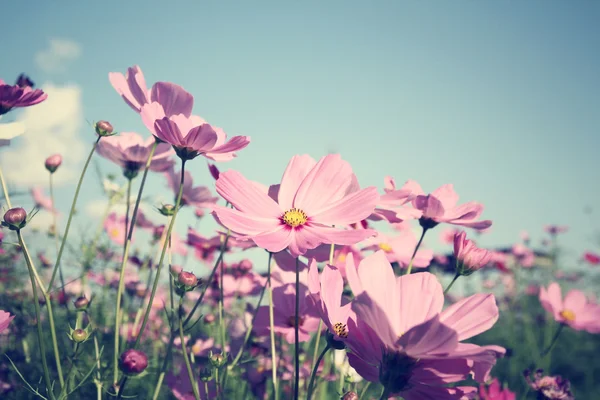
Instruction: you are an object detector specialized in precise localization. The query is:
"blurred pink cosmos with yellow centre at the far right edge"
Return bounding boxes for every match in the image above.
[539,282,600,333]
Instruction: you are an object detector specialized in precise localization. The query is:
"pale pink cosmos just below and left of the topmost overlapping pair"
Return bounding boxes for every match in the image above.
[97,132,175,176]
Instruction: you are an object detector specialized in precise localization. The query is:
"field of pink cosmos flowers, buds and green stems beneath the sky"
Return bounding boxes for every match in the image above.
[0,66,600,400]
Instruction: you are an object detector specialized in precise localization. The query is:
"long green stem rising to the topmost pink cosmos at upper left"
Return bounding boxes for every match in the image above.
[113,141,158,386]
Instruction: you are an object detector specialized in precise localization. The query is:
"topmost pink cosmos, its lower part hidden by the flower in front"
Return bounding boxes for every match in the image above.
[108,65,194,117]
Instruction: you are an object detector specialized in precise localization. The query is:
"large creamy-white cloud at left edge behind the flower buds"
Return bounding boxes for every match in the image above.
[1,84,85,187]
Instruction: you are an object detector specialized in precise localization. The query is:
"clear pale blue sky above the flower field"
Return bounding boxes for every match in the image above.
[0,1,600,272]
